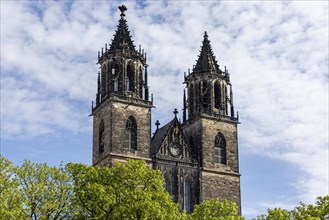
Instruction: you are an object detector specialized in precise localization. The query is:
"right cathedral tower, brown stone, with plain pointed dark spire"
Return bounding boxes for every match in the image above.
[182,32,241,210]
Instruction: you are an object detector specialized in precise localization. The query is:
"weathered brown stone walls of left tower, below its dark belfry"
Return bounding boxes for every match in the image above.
[93,97,151,165]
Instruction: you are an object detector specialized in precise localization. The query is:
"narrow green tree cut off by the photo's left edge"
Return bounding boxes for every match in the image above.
[0,155,25,219]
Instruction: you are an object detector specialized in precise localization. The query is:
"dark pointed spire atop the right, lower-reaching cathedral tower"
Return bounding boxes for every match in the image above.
[193,31,221,73]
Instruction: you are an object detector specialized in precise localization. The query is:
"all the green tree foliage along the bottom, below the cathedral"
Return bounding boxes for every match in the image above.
[0,155,329,220]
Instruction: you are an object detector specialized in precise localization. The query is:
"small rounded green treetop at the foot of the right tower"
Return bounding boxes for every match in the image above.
[189,199,244,220]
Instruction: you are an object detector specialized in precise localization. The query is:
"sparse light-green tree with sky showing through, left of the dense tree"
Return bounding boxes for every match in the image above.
[15,161,73,220]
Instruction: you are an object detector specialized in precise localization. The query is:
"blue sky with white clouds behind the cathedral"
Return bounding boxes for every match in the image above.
[0,0,329,218]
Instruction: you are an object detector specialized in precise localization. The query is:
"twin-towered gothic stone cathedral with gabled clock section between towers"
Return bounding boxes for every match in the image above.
[92,5,241,213]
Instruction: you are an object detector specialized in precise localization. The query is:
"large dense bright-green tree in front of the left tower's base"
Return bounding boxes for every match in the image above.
[67,160,182,219]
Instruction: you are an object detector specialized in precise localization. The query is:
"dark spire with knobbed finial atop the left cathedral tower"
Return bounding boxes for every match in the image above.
[110,5,135,51]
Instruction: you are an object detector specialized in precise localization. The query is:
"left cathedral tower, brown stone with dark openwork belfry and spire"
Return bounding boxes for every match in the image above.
[92,5,152,166]
